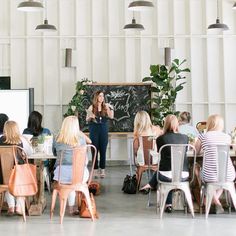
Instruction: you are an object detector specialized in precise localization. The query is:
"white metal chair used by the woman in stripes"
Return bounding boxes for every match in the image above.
[201,145,236,219]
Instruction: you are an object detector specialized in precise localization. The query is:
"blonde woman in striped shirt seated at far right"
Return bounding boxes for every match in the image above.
[195,115,235,214]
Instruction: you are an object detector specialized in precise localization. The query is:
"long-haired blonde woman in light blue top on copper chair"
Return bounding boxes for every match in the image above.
[53,116,91,214]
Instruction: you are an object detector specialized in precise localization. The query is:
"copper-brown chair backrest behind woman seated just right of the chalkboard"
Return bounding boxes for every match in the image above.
[133,136,155,165]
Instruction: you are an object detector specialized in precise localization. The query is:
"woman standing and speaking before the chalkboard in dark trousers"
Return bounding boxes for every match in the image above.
[86,91,114,178]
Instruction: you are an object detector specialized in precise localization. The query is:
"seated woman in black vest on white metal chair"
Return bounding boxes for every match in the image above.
[141,115,189,213]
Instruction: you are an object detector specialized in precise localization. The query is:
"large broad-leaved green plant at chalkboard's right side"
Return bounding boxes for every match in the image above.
[142,59,190,127]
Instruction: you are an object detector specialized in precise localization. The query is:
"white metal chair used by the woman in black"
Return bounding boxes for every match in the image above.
[157,144,196,219]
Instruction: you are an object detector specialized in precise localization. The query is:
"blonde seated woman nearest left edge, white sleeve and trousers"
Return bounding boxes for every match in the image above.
[0,121,33,215]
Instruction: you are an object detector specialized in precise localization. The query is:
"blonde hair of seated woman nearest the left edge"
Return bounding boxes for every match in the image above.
[3,120,22,145]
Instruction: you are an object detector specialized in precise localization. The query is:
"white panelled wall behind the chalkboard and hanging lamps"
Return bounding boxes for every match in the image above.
[0,0,236,158]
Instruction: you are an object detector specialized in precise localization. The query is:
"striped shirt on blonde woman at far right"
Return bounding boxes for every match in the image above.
[199,131,235,182]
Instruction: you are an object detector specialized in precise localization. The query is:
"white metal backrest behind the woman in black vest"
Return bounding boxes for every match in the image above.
[158,144,196,183]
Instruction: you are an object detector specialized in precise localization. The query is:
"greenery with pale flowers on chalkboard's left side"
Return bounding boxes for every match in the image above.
[64,78,92,117]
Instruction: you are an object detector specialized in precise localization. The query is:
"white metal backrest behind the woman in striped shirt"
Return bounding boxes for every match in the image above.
[203,144,230,183]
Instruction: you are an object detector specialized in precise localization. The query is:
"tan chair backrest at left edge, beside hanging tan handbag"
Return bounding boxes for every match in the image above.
[0,146,17,185]
